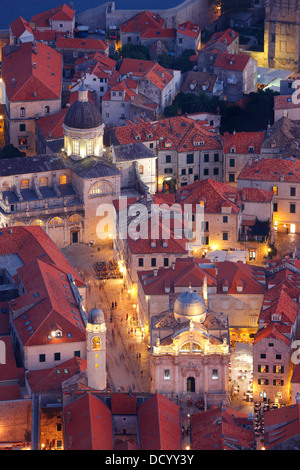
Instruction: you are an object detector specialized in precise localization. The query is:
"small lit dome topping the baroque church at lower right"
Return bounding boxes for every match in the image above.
[174,287,206,323]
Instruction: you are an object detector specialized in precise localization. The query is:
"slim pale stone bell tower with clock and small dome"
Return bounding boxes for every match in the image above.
[86,308,107,390]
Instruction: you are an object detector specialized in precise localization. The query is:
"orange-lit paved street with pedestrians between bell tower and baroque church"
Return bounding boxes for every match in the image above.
[63,245,151,392]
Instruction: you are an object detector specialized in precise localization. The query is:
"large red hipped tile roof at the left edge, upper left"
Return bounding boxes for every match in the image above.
[2,42,62,101]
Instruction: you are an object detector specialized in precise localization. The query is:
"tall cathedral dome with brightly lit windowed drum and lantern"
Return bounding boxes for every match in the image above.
[63,80,104,160]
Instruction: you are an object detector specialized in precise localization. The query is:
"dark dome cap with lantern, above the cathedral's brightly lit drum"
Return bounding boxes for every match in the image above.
[64,83,103,130]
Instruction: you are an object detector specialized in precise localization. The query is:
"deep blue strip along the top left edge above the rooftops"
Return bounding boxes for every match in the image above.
[0,0,183,29]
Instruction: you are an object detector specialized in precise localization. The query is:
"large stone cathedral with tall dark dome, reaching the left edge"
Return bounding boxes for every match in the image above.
[0,82,149,248]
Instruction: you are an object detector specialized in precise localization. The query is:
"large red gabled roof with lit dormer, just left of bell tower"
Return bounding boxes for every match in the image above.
[10,260,85,346]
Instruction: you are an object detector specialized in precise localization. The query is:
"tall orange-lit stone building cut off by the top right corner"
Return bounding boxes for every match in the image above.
[264,0,300,72]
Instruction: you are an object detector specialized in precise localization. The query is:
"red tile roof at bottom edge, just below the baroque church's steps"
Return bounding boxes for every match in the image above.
[191,407,255,451]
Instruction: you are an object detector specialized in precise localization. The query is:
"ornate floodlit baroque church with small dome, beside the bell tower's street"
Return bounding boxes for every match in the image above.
[150,288,230,406]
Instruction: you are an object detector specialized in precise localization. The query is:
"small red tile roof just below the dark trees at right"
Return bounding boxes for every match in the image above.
[221,132,265,154]
